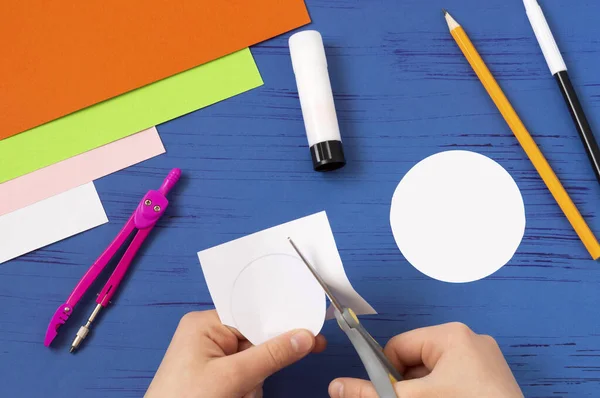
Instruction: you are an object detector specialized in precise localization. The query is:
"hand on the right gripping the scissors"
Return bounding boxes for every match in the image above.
[329,323,523,398]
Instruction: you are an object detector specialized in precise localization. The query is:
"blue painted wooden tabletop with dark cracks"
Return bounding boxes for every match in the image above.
[0,0,600,397]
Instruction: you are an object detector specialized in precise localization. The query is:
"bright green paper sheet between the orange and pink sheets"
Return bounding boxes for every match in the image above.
[0,49,263,183]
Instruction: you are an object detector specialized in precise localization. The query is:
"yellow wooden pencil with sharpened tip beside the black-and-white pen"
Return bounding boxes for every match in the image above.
[444,10,600,260]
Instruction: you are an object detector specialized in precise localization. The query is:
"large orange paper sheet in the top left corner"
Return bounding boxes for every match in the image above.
[0,0,310,139]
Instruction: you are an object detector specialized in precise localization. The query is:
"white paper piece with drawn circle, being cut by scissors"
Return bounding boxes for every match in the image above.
[198,212,376,344]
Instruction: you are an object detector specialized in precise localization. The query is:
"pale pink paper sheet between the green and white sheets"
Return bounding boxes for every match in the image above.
[0,127,165,216]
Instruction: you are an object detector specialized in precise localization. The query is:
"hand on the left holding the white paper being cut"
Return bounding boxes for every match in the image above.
[146,311,326,398]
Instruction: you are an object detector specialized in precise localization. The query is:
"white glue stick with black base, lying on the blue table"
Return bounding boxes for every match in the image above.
[289,30,346,171]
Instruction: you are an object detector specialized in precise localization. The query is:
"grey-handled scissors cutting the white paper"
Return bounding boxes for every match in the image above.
[288,238,402,398]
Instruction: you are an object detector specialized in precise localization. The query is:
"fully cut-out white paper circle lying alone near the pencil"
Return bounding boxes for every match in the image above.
[390,151,525,283]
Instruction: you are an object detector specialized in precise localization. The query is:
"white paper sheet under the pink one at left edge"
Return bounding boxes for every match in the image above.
[0,182,108,264]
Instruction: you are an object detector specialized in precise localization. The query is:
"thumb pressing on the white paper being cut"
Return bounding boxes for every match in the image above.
[227,330,315,389]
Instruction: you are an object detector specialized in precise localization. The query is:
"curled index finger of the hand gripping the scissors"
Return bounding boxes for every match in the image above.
[384,323,474,373]
